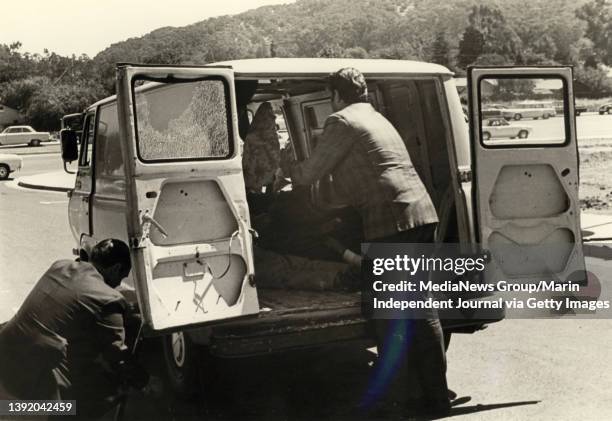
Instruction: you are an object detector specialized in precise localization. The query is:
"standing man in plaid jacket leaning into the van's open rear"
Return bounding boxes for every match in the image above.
[283,68,450,413]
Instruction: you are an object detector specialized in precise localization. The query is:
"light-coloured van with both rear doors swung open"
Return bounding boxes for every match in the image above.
[62,58,584,392]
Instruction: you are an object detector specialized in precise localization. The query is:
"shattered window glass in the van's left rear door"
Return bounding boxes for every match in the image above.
[134,78,232,162]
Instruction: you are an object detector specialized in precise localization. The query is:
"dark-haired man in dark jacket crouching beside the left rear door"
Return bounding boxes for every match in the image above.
[0,239,144,419]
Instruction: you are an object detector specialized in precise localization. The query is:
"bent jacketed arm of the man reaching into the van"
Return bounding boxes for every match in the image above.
[290,116,353,185]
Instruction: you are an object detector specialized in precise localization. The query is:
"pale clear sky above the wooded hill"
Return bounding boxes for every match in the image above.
[0,0,294,57]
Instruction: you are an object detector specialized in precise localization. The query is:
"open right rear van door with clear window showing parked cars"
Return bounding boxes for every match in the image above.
[468,67,585,282]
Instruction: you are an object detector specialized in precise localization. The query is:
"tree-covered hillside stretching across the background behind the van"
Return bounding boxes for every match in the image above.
[0,0,612,129]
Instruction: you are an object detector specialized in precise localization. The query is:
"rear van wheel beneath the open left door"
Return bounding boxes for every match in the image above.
[162,332,202,399]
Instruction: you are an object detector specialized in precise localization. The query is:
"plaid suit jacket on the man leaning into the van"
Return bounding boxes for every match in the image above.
[291,102,438,240]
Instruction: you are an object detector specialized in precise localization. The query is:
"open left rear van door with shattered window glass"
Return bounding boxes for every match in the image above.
[117,65,259,332]
